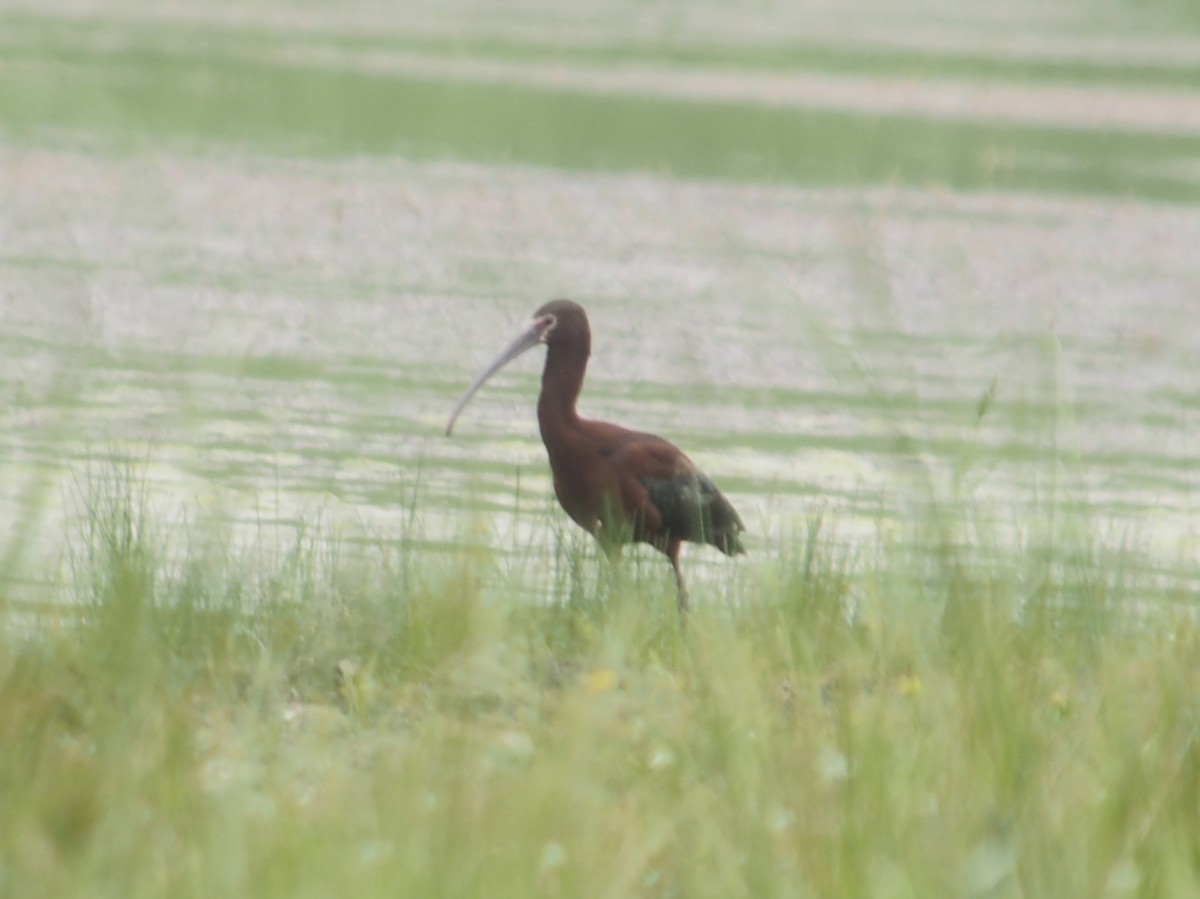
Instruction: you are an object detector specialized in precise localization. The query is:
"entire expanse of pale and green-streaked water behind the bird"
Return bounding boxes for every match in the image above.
[0,0,1200,602]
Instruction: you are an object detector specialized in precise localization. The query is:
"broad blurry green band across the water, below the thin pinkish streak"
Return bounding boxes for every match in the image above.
[0,12,1200,202]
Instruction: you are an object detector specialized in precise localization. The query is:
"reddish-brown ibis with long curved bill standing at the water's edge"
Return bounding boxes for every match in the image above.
[446,300,745,615]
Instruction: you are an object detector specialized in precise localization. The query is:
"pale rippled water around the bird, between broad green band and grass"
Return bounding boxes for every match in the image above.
[0,150,1200,592]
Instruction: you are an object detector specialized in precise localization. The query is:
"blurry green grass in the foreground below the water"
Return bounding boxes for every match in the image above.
[0,478,1200,899]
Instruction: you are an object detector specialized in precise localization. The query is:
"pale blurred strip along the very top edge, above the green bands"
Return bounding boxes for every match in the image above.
[18,0,1200,71]
